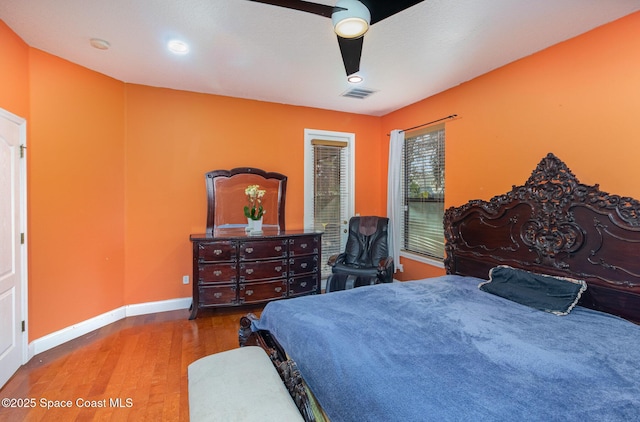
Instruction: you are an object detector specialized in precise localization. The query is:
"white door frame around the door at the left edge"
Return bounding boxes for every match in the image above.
[0,108,30,372]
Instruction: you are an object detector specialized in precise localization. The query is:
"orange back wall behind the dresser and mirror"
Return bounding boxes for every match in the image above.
[124,85,386,304]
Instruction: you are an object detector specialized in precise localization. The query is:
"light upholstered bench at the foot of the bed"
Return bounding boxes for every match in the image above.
[188,346,303,422]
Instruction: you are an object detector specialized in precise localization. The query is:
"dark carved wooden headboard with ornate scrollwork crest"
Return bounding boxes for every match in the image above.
[444,154,640,322]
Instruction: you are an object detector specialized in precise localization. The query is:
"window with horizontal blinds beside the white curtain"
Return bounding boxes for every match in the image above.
[402,125,445,259]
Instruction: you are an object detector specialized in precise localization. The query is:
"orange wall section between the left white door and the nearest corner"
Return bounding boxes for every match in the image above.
[28,49,125,339]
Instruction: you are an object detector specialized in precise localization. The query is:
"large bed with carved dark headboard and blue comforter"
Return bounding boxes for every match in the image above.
[240,154,640,422]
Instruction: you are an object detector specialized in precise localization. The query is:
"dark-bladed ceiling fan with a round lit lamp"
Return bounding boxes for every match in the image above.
[249,0,423,76]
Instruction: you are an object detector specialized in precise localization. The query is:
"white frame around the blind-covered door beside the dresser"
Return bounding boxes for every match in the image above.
[304,129,356,237]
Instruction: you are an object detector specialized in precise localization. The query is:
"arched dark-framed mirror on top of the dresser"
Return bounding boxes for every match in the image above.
[205,167,287,233]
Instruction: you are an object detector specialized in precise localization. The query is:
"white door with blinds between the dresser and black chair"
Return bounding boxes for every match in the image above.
[304,129,355,278]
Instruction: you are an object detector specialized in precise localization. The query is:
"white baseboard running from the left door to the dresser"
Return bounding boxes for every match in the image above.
[28,297,191,360]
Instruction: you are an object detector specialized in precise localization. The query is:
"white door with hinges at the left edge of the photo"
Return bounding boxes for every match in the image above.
[0,110,26,387]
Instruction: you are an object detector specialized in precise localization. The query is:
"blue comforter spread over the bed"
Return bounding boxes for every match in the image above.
[253,276,640,422]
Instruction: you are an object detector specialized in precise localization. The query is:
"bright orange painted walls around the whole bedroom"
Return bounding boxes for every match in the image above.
[0,13,640,340]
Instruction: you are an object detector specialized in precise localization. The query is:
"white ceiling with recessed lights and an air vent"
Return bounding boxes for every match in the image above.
[0,0,640,116]
